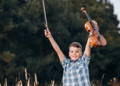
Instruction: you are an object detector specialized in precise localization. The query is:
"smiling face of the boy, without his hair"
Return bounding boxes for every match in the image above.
[69,46,82,61]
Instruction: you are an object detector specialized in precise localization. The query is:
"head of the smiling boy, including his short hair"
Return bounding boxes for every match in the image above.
[69,42,82,61]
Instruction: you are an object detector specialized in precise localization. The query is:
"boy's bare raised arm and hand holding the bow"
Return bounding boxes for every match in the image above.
[44,28,65,62]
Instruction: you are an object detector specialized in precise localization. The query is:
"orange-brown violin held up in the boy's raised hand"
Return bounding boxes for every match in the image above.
[81,7,107,47]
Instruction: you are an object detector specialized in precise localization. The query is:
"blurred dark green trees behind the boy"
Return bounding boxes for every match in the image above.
[0,0,120,86]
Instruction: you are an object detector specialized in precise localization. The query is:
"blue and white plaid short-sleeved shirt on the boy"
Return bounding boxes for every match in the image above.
[62,55,91,86]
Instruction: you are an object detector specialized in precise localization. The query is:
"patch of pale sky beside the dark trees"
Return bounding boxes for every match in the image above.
[110,0,120,27]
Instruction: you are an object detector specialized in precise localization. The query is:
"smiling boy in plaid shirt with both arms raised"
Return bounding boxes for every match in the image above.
[44,28,106,86]
